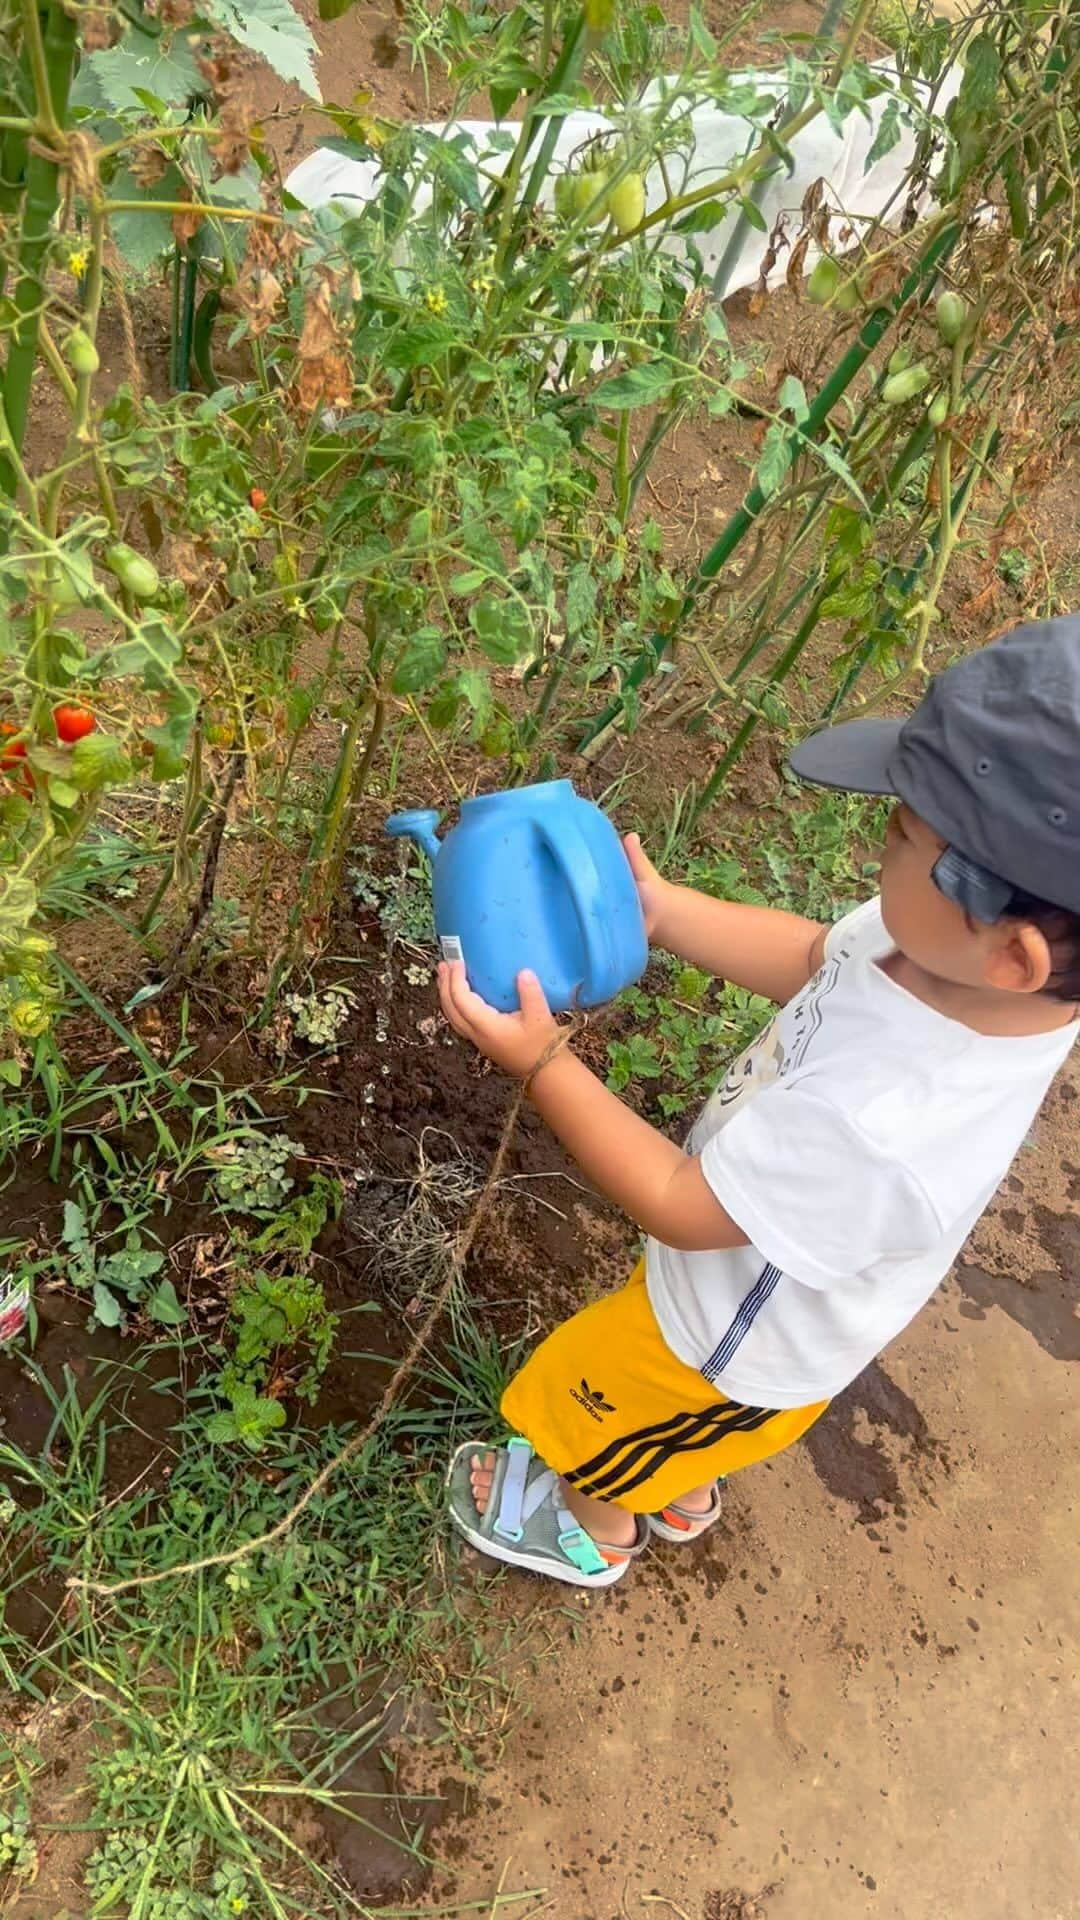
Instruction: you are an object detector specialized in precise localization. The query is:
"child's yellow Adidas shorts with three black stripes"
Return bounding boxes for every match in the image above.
[502,1260,828,1513]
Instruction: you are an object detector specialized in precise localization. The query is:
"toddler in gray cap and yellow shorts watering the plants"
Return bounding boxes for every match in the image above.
[438,616,1080,1588]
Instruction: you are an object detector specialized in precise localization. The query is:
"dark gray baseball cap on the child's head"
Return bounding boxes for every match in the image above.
[790,614,1080,925]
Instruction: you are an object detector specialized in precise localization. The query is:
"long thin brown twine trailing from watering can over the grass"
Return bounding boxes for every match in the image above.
[67,1016,584,1599]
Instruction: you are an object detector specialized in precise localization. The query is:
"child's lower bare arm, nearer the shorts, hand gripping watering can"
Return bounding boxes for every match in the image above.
[438,962,746,1252]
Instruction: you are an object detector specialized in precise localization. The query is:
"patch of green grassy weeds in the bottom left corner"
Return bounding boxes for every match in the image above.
[0,1351,522,1920]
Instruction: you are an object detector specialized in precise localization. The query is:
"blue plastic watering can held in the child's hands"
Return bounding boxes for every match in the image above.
[386,780,650,1014]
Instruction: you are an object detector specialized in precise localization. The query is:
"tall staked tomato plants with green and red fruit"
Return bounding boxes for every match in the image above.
[0,0,1080,1059]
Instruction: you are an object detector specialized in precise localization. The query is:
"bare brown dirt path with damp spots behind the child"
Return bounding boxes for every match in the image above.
[413,1062,1080,1920]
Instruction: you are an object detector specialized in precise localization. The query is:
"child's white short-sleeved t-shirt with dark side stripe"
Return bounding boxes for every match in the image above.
[648,900,1080,1407]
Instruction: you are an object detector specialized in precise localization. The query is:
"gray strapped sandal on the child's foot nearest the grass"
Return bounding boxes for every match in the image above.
[446,1434,650,1586]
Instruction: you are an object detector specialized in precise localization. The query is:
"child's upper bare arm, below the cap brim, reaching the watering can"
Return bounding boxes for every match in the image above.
[625,833,826,1004]
